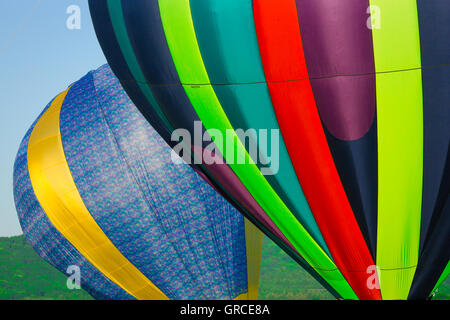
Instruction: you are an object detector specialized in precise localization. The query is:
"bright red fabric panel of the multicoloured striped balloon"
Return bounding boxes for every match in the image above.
[254,0,379,299]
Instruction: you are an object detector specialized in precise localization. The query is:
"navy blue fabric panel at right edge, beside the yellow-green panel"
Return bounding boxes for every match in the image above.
[410,0,450,298]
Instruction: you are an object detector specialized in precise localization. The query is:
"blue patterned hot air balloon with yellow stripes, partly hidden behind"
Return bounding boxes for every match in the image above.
[14,65,262,299]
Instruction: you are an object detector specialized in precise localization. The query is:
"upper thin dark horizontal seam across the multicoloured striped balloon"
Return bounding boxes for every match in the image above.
[117,63,450,87]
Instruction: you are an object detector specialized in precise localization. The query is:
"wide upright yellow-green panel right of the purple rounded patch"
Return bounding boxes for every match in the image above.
[370,0,423,299]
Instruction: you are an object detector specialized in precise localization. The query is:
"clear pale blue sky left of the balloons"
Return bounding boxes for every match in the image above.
[0,0,106,236]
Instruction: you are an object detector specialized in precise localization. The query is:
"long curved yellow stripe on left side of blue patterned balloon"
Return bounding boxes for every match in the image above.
[27,88,168,300]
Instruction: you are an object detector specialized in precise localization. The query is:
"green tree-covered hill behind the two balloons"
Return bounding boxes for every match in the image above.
[0,236,450,300]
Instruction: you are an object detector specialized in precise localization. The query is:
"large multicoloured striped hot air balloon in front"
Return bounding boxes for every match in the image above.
[89,0,450,299]
